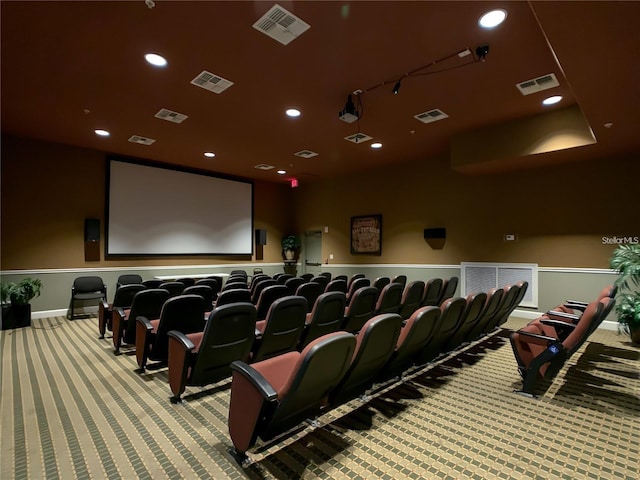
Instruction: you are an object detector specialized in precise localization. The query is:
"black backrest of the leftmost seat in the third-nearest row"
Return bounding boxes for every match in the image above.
[149,295,206,360]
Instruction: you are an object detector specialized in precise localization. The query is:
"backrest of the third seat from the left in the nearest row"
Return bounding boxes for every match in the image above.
[376,305,440,380]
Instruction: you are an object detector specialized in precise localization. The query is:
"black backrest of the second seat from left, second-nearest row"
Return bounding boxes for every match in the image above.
[252,295,307,362]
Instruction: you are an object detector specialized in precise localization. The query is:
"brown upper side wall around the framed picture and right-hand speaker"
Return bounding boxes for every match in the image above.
[295,152,640,268]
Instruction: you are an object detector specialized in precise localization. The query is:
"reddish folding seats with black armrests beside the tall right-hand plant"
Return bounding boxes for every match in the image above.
[510,286,617,397]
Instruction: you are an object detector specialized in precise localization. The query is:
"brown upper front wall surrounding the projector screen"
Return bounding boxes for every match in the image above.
[0,135,292,270]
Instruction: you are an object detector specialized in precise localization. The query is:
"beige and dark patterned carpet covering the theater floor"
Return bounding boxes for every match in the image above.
[0,317,640,480]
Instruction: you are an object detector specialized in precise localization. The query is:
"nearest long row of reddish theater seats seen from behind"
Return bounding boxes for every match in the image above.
[229,282,527,464]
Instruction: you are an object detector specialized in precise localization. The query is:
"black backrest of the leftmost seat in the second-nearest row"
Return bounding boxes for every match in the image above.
[189,302,256,385]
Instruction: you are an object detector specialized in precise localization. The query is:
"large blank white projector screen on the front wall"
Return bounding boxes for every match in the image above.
[105,159,253,256]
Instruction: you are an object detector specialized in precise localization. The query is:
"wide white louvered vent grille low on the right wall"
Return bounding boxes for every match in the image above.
[460,262,538,308]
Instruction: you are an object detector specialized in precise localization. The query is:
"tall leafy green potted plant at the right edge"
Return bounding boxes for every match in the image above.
[609,244,640,343]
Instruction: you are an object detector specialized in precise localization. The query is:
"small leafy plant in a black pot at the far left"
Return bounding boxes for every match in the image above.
[0,277,42,330]
